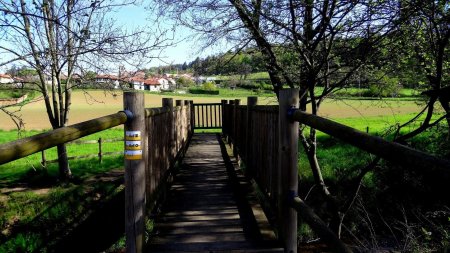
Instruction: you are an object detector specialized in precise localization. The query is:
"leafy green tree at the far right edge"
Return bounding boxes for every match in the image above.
[397,0,450,142]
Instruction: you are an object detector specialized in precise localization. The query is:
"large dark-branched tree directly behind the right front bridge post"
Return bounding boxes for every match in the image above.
[155,0,401,237]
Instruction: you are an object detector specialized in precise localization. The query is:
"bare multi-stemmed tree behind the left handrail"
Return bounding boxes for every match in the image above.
[0,0,170,178]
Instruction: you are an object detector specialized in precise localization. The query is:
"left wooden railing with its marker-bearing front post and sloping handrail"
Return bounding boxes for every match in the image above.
[0,92,193,253]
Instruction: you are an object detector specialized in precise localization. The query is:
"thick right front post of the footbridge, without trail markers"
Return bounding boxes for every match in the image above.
[278,89,299,252]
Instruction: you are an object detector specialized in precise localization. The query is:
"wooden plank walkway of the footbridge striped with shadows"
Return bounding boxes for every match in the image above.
[147,134,283,252]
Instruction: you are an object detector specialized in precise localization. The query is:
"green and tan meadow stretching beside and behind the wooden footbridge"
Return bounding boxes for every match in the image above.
[0,90,446,252]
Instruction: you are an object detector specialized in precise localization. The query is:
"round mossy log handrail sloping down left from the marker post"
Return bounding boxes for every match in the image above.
[0,112,127,164]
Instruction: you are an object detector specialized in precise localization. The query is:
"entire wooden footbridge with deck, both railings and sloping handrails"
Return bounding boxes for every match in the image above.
[0,89,450,253]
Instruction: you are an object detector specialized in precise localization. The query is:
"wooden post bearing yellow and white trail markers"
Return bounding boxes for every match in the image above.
[123,92,147,253]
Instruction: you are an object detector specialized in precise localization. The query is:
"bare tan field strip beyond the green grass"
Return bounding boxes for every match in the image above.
[0,91,419,130]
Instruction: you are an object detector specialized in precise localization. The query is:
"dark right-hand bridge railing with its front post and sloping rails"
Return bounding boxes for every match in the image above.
[222,89,450,252]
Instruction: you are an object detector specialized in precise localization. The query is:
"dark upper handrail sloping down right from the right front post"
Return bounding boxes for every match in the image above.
[288,110,450,176]
